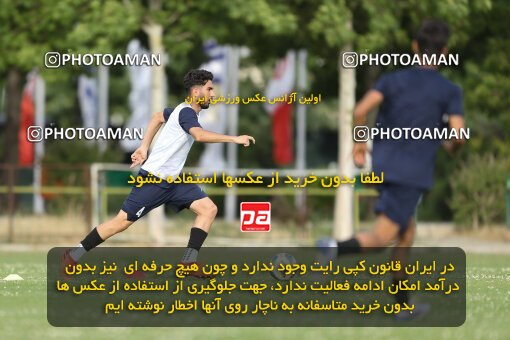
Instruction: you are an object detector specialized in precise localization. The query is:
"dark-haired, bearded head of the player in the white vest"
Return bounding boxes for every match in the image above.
[184,70,214,109]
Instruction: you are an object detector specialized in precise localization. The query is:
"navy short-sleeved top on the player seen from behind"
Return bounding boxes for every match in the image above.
[372,67,464,189]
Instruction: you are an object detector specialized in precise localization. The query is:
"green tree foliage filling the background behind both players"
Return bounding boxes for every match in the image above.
[0,0,510,224]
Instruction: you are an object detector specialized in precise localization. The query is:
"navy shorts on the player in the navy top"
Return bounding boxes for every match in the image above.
[375,183,424,235]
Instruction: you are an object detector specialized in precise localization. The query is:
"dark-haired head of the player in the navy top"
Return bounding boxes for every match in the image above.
[413,19,450,56]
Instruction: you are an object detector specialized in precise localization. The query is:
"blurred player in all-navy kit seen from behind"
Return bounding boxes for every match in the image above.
[319,20,464,318]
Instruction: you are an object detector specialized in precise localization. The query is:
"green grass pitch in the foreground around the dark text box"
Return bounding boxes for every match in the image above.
[0,251,510,340]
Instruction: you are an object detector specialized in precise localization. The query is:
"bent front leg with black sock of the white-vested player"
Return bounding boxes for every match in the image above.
[182,197,218,263]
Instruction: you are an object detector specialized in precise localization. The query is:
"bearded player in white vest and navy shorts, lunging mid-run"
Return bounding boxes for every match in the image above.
[64,70,255,276]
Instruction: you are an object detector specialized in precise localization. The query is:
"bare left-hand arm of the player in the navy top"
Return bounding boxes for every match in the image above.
[352,90,384,168]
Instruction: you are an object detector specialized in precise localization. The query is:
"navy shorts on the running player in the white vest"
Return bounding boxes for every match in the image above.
[122,169,207,222]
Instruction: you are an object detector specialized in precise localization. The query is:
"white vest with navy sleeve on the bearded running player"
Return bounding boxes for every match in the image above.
[142,102,201,180]
